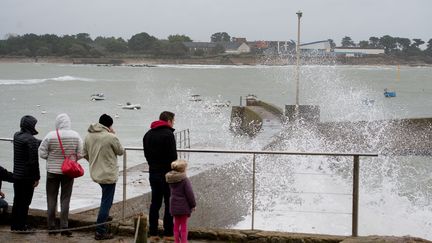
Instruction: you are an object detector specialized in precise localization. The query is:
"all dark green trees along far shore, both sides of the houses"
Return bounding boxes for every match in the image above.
[0,32,432,57]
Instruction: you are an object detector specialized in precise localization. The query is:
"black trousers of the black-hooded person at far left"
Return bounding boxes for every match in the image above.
[11,180,35,230]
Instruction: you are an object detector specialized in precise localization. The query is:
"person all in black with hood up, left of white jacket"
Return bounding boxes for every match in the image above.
[11,116,41,231]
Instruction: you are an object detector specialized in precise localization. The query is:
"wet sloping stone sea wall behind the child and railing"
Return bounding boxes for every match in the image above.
[76,158,252,228]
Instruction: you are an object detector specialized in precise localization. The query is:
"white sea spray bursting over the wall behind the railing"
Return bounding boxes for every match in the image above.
[236,53,432,239]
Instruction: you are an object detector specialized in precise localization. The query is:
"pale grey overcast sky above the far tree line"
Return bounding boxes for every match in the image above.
[0,0,432,45]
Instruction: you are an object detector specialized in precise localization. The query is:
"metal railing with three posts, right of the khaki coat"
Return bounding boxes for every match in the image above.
[122,147,378,236]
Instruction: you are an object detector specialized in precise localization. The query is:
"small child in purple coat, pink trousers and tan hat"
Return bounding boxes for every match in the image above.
[165,160,196,243]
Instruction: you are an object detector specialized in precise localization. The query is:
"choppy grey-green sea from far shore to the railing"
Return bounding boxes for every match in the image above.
[0,63,432,240]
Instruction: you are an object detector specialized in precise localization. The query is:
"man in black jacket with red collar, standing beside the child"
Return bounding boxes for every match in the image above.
[143,111,177,241]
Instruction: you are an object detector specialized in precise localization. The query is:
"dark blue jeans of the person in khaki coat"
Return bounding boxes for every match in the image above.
[96,183,115,234]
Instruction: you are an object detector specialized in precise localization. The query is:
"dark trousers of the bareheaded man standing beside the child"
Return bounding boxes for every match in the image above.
[149,172,174,236]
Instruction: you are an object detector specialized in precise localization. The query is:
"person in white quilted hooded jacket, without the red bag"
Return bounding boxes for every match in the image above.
[39,113,83,237]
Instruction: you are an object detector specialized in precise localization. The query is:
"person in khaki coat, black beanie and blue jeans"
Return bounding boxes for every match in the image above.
[83,114,123,240]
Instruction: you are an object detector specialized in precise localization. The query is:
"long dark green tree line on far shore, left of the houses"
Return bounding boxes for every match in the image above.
[0,32,192,57]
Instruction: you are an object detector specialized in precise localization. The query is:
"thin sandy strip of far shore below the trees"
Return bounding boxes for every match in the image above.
[0,56,432,67]
